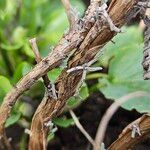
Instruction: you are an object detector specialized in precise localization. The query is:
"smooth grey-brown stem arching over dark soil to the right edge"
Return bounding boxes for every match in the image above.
[93,91,150,150]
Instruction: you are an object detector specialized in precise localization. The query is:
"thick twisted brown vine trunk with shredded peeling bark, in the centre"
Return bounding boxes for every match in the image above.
[29,0,144,149]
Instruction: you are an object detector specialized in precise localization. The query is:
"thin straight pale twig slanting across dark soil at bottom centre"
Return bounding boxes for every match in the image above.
[69,110,95,146]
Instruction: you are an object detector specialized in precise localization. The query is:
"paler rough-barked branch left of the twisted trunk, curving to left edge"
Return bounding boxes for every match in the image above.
[0,0,99,145]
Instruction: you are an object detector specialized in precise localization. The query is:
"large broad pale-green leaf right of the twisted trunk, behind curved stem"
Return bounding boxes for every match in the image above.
[99,44,150,112]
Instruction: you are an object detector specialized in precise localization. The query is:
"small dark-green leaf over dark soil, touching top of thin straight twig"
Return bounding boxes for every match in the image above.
[53,117,74,128]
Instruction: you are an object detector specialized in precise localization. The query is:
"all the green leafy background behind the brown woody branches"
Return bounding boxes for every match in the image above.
[0,0,150,147]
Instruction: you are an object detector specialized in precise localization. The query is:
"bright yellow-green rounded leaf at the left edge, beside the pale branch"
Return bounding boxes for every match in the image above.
[0,76,12,101]
